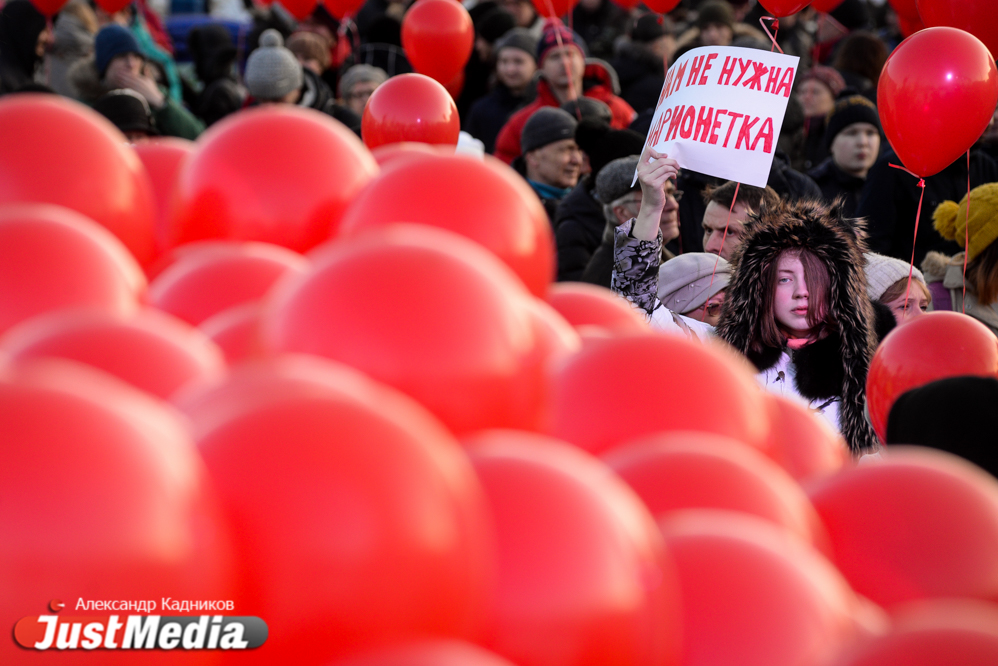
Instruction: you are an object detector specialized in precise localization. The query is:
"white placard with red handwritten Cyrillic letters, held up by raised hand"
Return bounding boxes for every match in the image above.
[635,46,800,187]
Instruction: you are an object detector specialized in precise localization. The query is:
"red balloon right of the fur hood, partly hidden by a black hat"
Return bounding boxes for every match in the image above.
[866,312,998,441]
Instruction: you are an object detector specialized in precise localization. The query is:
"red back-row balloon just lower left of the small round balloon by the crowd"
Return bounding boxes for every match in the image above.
[169,104,378,252]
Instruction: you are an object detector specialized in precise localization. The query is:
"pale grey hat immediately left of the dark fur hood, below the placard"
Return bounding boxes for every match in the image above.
[658,252,731,314]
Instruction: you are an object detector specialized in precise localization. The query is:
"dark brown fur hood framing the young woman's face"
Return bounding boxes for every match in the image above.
[717,200,878,453]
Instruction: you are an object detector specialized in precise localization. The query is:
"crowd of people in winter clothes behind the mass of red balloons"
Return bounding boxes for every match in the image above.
[0,0,998,466]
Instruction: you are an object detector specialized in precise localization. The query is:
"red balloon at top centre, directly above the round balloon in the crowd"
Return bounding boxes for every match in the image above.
[402,0,475,85]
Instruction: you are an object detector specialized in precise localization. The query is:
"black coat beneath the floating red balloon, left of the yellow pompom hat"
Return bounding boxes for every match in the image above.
[856,150,998,266]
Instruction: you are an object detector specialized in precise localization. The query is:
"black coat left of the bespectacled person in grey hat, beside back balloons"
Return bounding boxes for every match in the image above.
[554,176,606,282]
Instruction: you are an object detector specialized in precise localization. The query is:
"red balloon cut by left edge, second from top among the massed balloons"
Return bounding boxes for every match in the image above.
[0,202,146,333]
